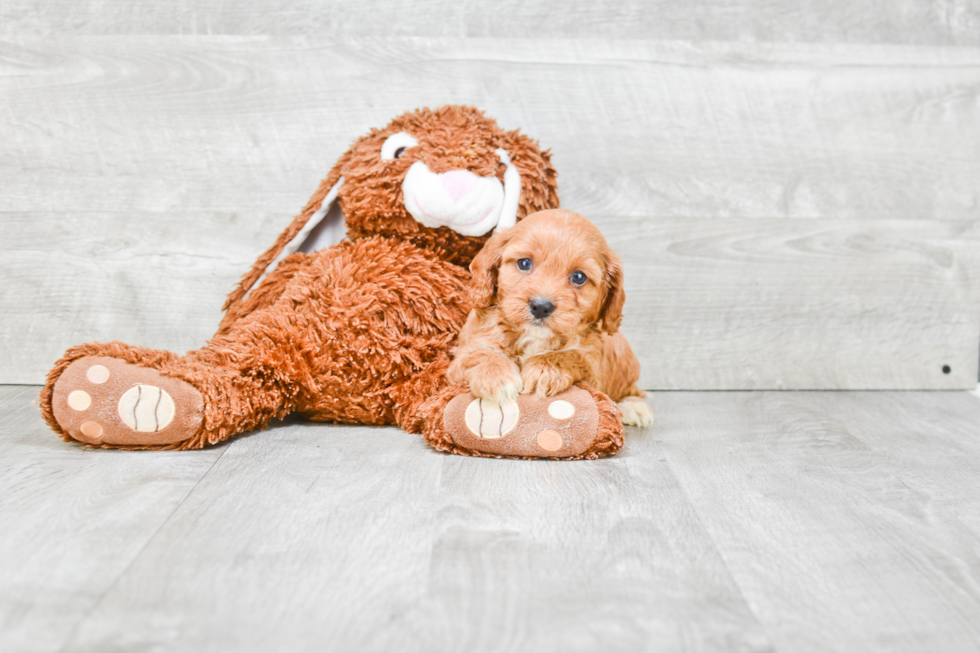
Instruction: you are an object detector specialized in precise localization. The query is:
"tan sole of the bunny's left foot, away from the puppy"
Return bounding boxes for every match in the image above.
[51,356,204,447]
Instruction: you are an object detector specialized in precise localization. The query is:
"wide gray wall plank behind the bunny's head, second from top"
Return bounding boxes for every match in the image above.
[0,36,980,222]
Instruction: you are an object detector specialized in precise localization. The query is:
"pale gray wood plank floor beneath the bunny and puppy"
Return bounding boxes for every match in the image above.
[0,386,980,652]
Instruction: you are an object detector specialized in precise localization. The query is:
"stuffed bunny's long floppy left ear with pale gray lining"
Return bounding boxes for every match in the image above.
[222,151,350,313]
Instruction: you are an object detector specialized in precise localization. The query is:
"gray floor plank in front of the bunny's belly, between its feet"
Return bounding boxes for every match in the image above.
[64,412,444,652]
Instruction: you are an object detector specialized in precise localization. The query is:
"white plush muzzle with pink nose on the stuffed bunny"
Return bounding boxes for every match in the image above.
[402,149,521,236]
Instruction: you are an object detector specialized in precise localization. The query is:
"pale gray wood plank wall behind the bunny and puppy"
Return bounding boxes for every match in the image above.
[0,0,980,389]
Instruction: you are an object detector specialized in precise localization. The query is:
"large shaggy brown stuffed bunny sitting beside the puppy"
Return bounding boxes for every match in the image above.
[40,106,623,458]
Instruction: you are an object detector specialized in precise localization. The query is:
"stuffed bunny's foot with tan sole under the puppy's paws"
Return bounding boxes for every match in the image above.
[442,387,623,460]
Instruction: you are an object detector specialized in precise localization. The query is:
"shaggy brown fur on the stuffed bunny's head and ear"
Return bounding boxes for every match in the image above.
[220,106,558,331]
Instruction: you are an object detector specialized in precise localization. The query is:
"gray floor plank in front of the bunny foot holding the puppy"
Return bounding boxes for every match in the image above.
[410,454,771,651]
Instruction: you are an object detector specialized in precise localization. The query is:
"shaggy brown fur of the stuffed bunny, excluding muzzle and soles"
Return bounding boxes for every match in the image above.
[40,106,621,453]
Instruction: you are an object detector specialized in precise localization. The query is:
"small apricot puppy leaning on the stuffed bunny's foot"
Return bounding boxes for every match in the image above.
[448,209,653,426]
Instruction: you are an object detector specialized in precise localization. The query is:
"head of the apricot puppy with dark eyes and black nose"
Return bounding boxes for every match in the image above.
[473,210,625,335]
